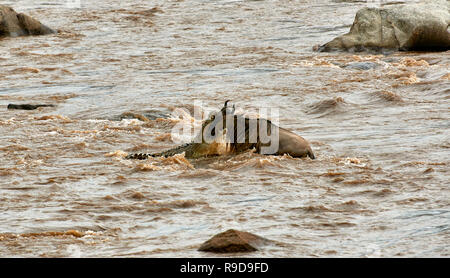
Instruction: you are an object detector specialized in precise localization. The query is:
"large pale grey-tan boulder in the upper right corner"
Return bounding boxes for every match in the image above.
[318,0,450,52]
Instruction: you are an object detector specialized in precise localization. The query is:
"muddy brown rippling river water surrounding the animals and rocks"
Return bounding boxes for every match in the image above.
[0,0,450,257]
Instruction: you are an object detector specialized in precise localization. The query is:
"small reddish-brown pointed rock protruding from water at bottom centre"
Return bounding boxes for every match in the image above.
[198,229,271,253]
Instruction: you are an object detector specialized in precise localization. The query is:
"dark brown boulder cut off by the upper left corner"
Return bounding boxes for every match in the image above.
[0,5,55,38]
